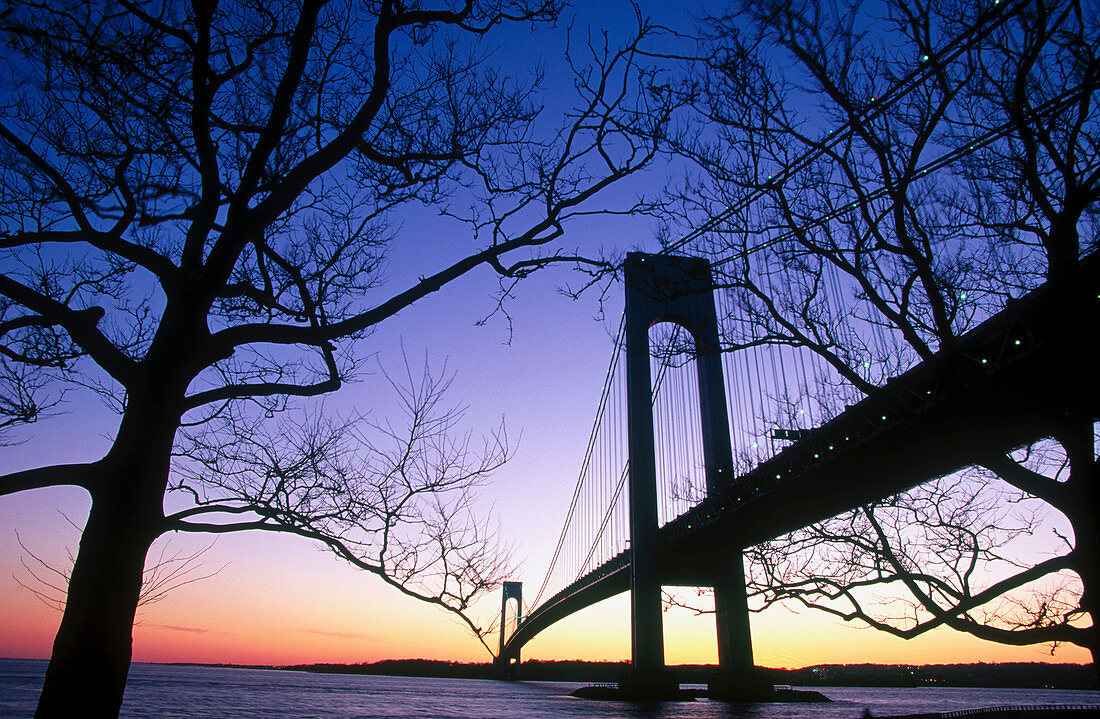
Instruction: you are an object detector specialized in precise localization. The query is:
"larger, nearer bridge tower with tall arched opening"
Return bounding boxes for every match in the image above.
[623,252,757,696]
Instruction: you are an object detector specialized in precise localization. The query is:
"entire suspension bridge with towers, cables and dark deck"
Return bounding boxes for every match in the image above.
[498,253,1100,696]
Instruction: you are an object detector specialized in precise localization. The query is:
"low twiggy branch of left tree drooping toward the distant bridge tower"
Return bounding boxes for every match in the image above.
[165,361,513,653]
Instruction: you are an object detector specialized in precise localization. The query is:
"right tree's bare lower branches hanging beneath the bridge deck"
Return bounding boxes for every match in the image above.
[746,461,1089,652]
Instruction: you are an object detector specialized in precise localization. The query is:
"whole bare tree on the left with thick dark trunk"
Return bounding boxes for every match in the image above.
[0,0,669,717]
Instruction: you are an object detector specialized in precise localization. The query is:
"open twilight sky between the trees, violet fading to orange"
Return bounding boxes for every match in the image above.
[0,3,1090,667]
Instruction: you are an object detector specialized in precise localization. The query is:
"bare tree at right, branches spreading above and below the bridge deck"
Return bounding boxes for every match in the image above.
[655,0,1100,664]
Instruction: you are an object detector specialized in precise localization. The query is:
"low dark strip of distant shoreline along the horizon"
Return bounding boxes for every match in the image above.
[207,660,1100,689]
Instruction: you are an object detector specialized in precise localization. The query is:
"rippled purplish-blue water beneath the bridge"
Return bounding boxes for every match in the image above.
[0,660,1100,719]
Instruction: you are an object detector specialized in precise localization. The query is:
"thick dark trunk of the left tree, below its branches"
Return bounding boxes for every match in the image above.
[34,393,178,719]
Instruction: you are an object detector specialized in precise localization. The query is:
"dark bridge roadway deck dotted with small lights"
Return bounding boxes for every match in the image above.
[505,280,1100,655]
